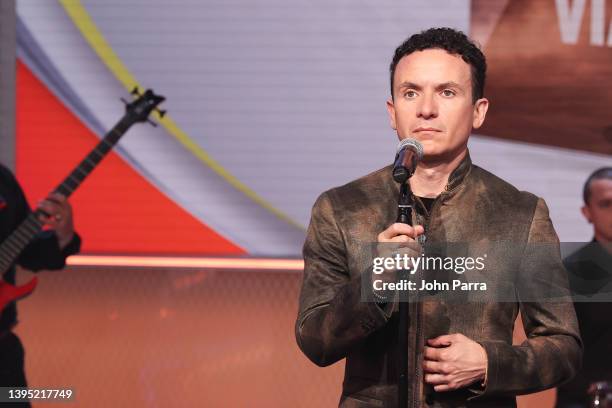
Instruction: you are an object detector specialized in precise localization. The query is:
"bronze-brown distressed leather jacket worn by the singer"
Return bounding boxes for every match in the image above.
[295,154,582,407]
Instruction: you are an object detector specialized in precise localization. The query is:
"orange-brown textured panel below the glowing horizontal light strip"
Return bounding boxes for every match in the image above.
[16,266,554,408]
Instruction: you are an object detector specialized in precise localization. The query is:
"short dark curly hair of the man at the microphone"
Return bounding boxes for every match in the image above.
[389,27,487,102]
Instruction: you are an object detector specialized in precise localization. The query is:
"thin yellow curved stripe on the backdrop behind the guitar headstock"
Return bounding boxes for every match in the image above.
[60,0,303,230]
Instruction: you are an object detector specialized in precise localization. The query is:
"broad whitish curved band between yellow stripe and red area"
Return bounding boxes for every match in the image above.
[18,2,304,256]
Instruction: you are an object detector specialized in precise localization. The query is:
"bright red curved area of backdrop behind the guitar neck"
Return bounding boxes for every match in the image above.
[16,61,244,255]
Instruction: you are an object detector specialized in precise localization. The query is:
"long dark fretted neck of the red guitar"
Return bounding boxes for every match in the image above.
[0,115,133,274]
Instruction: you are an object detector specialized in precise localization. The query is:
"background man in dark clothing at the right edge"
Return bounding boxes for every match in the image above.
[557,167,612,408]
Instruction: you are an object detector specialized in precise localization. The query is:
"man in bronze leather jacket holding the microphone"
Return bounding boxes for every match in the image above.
[295,28,582,407]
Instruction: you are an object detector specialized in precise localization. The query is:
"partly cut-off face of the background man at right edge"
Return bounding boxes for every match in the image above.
[582,179,612,242]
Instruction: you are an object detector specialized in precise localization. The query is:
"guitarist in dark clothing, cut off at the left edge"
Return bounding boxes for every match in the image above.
[0,165,81,406]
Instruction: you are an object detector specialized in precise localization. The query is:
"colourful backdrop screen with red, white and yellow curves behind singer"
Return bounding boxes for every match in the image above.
[16,0,612,257]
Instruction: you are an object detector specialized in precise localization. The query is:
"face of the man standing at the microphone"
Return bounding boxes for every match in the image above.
[387,49,488,162]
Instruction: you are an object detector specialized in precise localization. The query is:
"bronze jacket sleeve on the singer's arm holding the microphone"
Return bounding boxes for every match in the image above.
[295,193,389,366]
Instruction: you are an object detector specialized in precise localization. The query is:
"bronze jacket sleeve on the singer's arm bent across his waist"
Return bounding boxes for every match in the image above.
[480,199,582,395]
